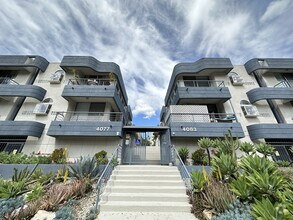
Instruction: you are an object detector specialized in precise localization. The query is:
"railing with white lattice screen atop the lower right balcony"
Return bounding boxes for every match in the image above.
[166,113,238,124]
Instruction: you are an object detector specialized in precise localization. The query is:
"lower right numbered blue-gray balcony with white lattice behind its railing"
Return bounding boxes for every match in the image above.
[166,113,244,138]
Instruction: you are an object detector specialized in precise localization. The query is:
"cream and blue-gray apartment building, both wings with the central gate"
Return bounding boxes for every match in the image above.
[0,56,293,164]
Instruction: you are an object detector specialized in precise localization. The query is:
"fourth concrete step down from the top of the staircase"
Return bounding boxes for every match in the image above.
[108,179,183,186]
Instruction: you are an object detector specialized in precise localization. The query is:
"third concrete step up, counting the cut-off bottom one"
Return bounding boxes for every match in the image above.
[102,193,188,202]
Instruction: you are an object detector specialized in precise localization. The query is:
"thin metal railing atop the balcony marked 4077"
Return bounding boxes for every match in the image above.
[55,112,123,122]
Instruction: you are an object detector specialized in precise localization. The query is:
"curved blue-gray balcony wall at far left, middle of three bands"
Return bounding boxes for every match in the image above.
[0,85,47,101]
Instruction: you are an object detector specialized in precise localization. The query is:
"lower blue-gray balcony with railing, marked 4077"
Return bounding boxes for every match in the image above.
[47,112,124,137]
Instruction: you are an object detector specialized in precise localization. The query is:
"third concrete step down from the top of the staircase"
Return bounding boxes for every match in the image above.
[110,174,181,180]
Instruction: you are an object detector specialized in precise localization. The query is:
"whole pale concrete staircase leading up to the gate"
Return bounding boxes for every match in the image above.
[99,165,195,220]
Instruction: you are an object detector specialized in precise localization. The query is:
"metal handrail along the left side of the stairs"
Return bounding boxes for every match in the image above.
[95,145,121,213]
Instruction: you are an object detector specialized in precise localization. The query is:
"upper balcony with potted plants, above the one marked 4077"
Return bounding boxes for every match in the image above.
[62,78,126,112]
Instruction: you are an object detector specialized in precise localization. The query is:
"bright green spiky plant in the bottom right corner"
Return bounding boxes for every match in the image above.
[251,198,292,220]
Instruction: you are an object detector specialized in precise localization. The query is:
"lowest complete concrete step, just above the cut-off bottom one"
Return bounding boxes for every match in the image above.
[101,201,191,212]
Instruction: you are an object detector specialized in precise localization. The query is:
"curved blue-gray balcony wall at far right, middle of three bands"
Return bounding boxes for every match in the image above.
[246,87,293,103]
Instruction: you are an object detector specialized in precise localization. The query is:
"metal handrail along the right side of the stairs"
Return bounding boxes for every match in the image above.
[170,145,193,195]
